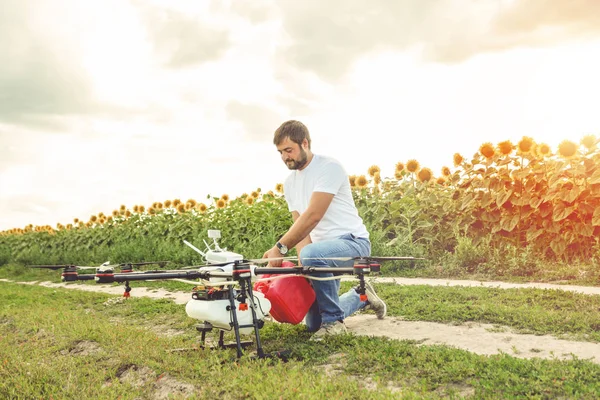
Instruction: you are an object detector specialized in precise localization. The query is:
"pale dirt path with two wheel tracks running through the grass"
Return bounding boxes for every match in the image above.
[0,278,600,364]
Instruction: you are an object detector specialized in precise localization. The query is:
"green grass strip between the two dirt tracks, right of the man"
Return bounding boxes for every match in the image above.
[354,282,600,342]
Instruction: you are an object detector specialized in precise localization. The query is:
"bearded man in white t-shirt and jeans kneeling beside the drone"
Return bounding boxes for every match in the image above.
[263,120,386,340]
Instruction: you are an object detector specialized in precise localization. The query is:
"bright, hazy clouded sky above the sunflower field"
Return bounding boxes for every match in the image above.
[0,0,600,229]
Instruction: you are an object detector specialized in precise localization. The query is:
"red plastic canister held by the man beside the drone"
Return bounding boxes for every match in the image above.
[254,261,316,325]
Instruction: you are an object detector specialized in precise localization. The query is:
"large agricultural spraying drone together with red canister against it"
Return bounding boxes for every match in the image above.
[28,230,422,358]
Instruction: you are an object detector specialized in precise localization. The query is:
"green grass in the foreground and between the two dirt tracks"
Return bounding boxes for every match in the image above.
[0,282,600,399]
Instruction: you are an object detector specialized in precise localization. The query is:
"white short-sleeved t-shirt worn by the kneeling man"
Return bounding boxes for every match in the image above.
[283,154,369,242]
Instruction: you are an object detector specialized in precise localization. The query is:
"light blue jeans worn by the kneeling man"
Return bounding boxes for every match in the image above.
[300,234,371,332]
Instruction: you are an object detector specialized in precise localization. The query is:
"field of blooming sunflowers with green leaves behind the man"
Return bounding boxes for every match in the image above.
[0,135,600,275]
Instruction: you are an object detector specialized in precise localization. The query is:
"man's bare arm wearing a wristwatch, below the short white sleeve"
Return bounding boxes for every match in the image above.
[263,192,334,267]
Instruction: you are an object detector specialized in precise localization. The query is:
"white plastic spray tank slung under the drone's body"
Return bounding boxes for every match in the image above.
[185,291,271,334]
